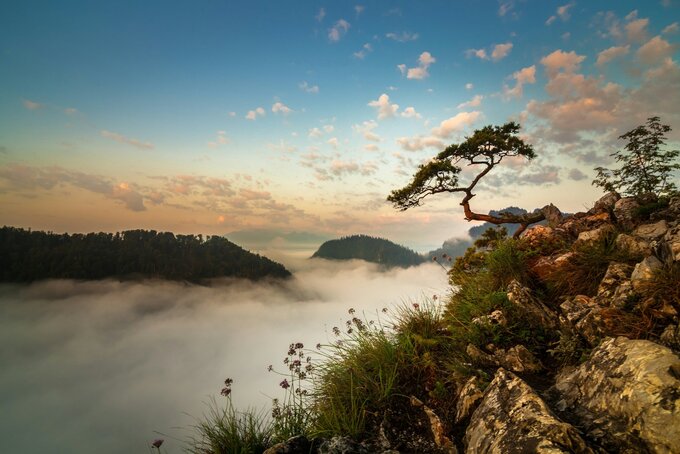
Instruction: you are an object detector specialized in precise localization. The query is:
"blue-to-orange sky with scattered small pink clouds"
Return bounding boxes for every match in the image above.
[0,0,680,250]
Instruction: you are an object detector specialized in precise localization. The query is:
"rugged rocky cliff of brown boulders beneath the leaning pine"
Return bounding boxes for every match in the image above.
[269,193,680,454]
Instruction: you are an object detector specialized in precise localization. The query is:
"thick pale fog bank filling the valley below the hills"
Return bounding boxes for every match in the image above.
[0,260,447,453]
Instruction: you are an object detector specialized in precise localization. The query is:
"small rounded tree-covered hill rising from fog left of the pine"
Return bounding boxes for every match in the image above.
[312,235,425,267]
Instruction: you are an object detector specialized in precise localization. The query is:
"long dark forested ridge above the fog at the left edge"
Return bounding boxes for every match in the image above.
[0,227,290,282]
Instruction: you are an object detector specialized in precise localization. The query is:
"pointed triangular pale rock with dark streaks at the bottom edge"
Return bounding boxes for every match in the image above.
[465,369,593,454]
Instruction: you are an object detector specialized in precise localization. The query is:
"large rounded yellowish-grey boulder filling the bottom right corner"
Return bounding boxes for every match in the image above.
[554,337,680,454]
